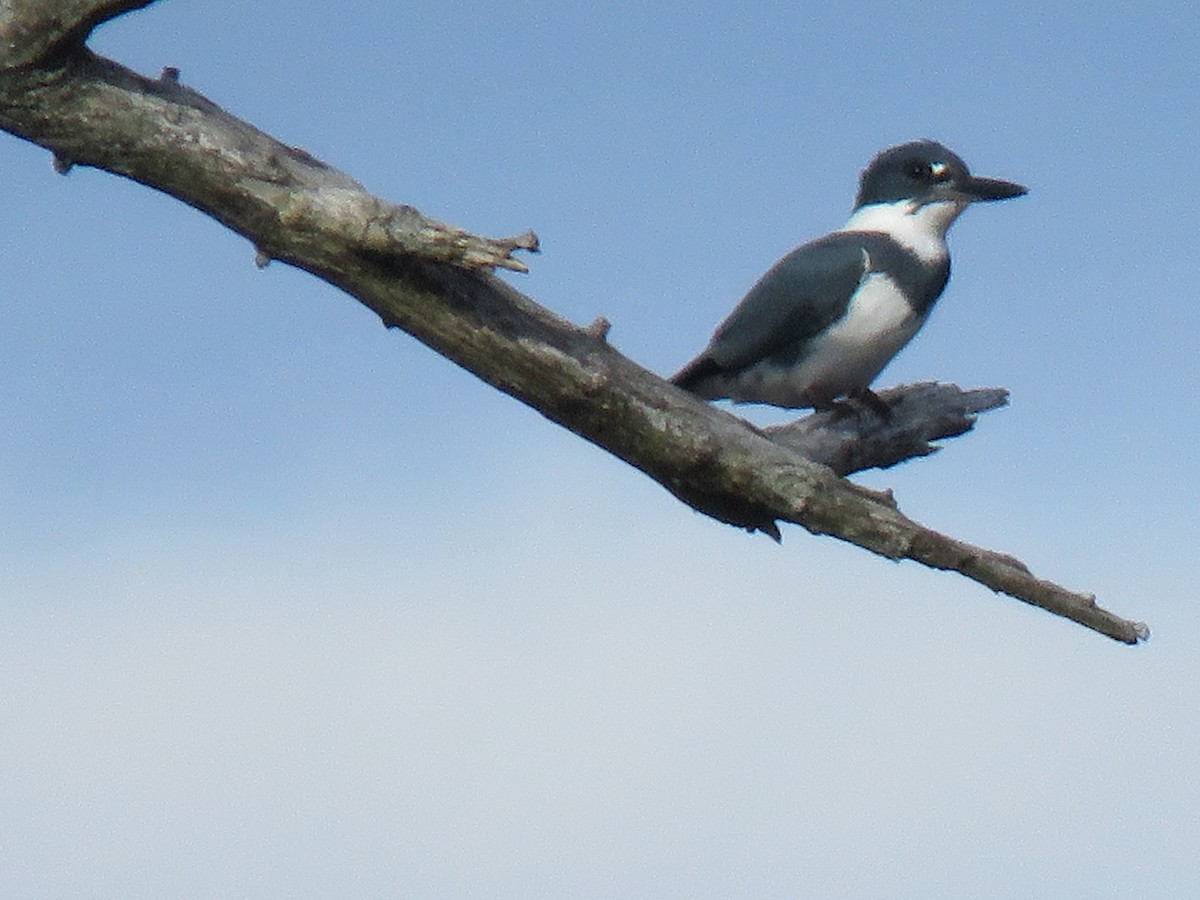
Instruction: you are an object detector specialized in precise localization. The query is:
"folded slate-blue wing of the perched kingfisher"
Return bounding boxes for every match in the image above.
[697,233,870,371]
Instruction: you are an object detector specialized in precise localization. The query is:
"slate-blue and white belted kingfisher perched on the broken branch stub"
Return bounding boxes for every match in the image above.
[671,140,1026,414]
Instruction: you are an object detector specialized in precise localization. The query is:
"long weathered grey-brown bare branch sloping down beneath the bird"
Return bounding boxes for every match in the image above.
[0,0,1147,643]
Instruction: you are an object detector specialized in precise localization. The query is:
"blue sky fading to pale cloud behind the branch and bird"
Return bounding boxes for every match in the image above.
[0,0,1200,899]
